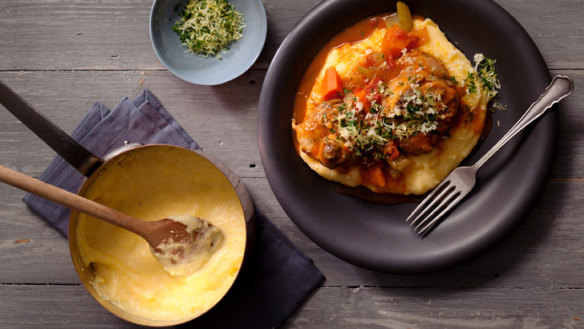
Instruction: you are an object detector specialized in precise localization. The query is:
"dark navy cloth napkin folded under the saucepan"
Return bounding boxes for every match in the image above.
[24,90,324,329]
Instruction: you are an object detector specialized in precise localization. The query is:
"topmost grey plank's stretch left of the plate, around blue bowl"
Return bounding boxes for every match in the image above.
[0,0,319,70]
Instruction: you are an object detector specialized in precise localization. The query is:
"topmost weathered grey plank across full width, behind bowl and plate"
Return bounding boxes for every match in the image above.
[0,0,584,70]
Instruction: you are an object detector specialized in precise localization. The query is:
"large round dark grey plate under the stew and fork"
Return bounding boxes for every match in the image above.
[258,0,557,273]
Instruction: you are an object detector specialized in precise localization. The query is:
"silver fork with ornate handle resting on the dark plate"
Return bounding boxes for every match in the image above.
[406,76,574,236]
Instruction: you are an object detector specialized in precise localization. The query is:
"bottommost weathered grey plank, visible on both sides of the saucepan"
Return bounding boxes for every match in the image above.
[0,285,584,329]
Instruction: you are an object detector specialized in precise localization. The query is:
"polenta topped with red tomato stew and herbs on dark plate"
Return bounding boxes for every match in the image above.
[292,9,499,195]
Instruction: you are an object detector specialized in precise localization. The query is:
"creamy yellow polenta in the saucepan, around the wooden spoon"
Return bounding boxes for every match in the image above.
[75,147,246,322]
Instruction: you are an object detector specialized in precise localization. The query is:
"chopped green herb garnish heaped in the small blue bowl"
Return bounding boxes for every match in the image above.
[172,0,245,58]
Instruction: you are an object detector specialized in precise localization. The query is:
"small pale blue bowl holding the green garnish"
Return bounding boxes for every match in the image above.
[150,0,268,85]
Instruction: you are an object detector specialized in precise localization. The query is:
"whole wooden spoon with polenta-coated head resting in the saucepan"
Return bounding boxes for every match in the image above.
[0,166,224,275]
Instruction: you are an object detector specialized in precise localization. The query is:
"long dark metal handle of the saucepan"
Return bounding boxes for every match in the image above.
[0,80,103,177]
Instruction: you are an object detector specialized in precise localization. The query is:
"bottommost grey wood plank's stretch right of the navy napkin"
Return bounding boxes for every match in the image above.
[284,287,584,329]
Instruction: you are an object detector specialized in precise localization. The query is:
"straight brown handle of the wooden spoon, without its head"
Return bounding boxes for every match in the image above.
[0,166,148,240]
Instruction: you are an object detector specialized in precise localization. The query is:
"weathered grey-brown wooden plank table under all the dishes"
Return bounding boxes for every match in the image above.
[0,0,584,329]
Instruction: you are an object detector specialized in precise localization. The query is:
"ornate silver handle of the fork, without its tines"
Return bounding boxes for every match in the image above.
[472,75,574,170]
